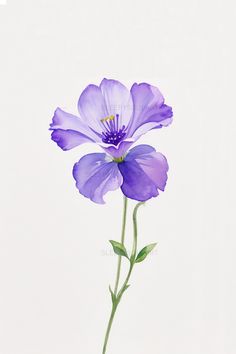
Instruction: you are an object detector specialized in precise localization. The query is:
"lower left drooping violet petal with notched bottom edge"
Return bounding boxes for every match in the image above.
[73,153,123,204]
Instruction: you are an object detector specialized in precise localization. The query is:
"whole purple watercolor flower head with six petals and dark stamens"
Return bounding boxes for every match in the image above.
[50,79,172,203]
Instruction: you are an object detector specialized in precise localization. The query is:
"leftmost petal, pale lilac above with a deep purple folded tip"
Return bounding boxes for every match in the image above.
[50,108,99,150]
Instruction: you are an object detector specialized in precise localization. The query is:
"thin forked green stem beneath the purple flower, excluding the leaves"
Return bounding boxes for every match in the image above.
[102,202,144,354]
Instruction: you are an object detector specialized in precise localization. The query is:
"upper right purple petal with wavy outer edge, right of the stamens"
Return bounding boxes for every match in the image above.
[127,83,173,140]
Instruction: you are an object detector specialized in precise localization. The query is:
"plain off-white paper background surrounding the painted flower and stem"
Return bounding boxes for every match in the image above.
[0,0,236,354]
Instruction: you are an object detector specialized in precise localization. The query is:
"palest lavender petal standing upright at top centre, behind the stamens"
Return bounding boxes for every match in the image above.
[100,79,133,126]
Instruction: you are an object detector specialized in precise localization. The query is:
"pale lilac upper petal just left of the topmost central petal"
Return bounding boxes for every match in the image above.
[78,85,108,134]
